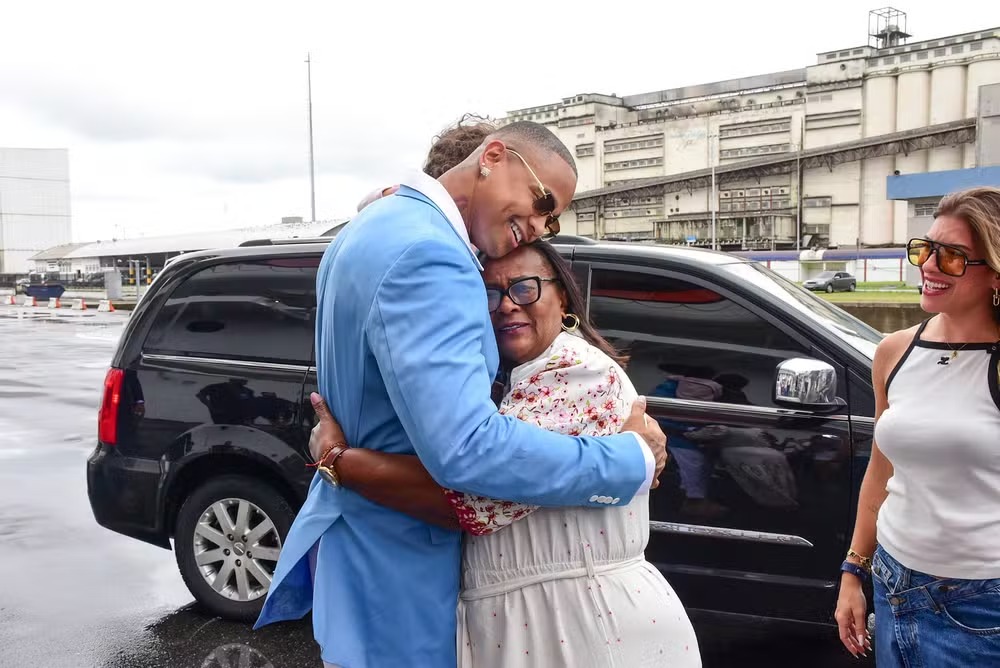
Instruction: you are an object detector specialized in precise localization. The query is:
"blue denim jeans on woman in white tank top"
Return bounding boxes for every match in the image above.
[872,547,1000,668]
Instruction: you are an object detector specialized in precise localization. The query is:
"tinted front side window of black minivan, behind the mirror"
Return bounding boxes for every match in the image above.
[590,268,810,406]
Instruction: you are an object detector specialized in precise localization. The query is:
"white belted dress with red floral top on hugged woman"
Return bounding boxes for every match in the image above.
[448,333,701,668]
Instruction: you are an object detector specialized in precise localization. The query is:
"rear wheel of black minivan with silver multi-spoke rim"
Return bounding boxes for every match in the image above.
[174,475,295,622]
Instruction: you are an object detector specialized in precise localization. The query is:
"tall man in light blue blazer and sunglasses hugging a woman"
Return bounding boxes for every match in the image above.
[257,123,665,668]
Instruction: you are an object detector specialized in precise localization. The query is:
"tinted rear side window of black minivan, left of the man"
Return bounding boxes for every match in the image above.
[144,258,319,364]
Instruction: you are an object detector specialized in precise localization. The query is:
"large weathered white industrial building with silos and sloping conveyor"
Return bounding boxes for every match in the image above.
[505,8,1000,250]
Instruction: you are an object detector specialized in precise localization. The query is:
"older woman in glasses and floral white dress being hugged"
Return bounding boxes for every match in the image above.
[310,242,701,668]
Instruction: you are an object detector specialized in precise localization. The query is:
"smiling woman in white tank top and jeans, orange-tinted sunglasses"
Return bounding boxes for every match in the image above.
[836,188,1000,668]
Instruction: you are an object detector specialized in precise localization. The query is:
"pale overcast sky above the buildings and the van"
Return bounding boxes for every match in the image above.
[0,0,1000,241]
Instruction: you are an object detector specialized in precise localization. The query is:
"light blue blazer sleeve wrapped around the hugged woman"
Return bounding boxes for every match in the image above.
[366,239,646,506]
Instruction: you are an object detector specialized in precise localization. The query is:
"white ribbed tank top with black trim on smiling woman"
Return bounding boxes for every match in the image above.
[875,322,1000,580]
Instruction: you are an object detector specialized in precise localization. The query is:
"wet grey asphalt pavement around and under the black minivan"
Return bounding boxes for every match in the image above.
[0,307,858,668]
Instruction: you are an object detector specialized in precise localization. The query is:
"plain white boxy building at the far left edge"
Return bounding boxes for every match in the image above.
[0,148,72,274]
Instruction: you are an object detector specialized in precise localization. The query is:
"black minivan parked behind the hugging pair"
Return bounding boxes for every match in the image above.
[87,239,882,623]
